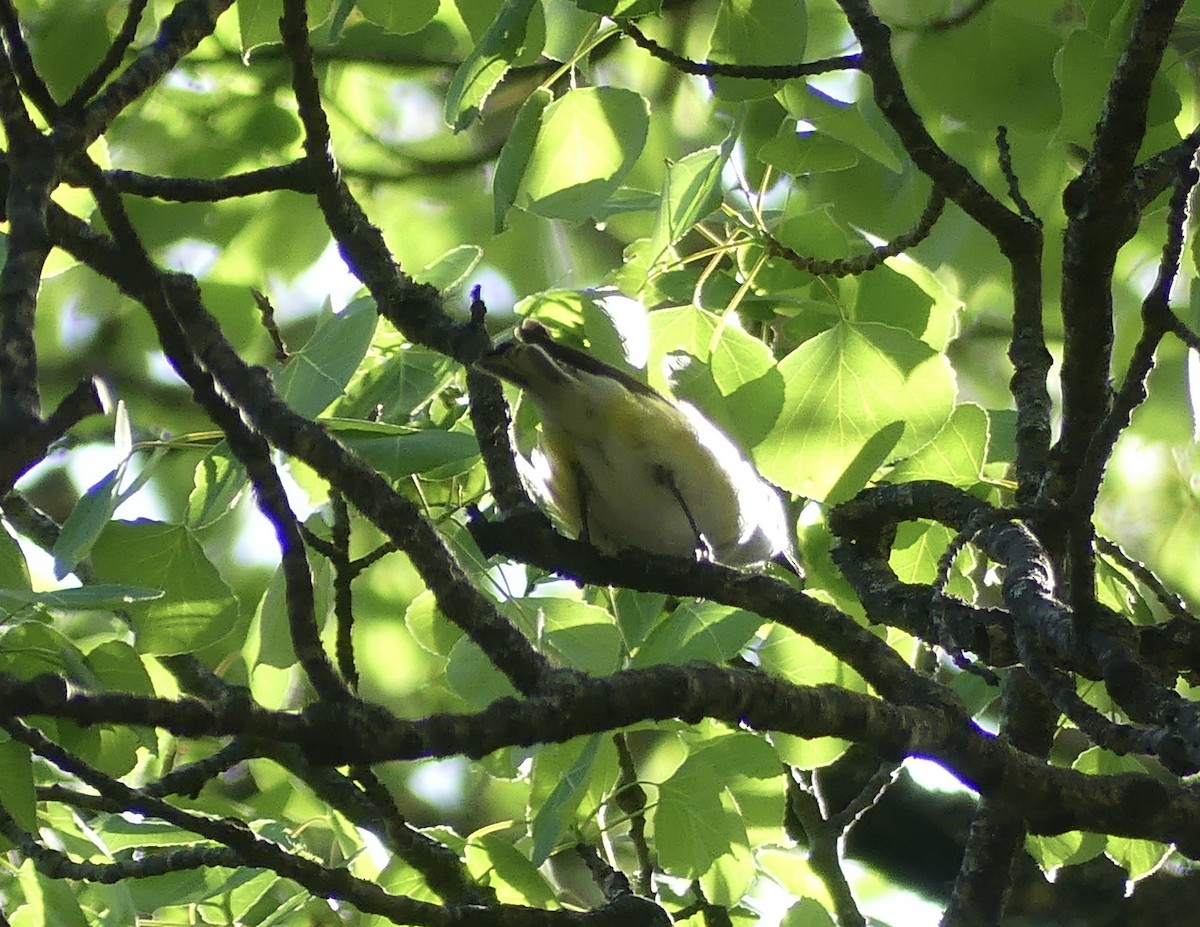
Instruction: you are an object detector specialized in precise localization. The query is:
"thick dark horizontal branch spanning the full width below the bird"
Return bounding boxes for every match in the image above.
[0,664,1200,854]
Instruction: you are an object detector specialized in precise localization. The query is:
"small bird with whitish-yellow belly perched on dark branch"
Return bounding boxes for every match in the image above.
[476,321,803,576]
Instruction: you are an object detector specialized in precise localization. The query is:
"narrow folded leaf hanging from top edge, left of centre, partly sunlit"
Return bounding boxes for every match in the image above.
[445,0,545,132]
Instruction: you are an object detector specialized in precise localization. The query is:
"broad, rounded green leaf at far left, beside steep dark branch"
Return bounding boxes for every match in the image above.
[92,520,238,654]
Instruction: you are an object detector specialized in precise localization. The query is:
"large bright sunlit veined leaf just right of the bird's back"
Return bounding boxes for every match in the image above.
[755,322,955,498]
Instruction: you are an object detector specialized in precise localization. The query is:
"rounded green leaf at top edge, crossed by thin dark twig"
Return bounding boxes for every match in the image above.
[708,0,808,101]
